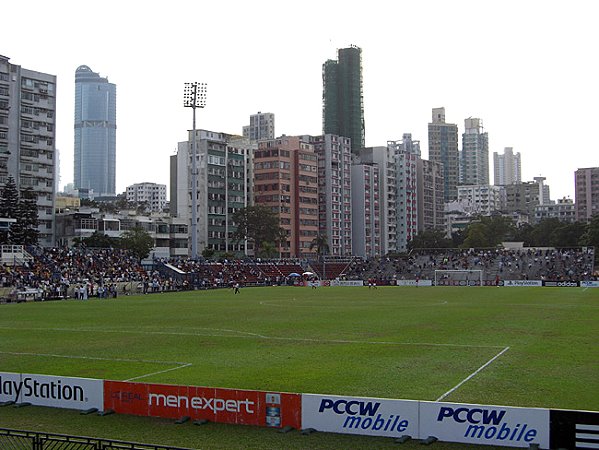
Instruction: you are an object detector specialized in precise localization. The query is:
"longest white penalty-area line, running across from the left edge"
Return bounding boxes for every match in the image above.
[0,326,503,350]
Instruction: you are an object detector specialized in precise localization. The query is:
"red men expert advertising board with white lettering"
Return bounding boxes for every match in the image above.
[104,381,302,429]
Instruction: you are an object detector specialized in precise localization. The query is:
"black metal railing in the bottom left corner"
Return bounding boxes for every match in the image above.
[0,428,192,450]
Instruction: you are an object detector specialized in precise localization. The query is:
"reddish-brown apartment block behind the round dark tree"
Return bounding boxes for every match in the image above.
[254,136,319,258]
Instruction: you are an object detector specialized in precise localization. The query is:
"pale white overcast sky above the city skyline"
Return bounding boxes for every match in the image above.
[0,0,599,200]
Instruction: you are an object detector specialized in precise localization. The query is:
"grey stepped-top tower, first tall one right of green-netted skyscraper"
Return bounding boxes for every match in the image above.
[428,108,459,202]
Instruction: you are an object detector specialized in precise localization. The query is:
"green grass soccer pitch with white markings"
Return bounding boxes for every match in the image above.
[0,287,599,410]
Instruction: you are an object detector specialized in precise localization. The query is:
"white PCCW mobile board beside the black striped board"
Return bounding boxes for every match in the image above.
[420,402,549,449]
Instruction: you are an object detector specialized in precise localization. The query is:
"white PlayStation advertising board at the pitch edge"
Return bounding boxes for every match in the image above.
[0,373,104,410]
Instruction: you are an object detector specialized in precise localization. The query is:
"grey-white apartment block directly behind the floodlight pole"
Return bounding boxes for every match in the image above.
[176,130,255,257]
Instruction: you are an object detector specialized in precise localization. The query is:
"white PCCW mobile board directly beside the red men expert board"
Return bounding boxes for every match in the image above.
[302,394,418,439]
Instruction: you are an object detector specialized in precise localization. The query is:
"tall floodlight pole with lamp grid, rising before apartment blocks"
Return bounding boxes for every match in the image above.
[183,81,206,259]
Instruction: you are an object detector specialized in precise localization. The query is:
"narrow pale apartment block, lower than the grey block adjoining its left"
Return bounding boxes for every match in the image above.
[351,163,382,258]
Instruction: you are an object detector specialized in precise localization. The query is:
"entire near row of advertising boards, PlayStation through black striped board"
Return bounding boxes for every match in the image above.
[0,372,599,449]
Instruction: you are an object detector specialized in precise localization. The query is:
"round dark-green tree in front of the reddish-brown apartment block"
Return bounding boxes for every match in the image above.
[232,205,285,255]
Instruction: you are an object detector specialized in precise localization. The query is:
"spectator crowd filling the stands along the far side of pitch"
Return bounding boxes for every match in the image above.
[0,244,596,299]
